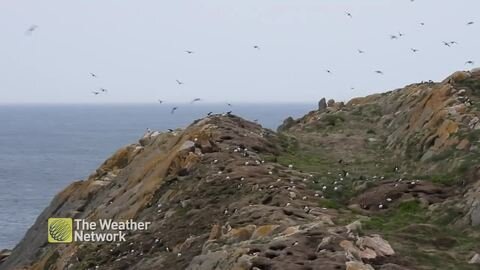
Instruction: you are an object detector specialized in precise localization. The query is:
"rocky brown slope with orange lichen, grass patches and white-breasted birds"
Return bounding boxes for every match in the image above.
[0,71,480,270]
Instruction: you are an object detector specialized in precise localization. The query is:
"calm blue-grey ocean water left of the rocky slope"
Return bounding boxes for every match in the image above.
[0,103,315,250]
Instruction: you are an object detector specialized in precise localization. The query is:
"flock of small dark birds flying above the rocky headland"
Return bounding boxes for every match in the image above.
[25,6,475,115]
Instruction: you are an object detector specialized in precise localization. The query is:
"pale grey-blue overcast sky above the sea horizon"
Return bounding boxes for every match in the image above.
[0,0,480,104]
